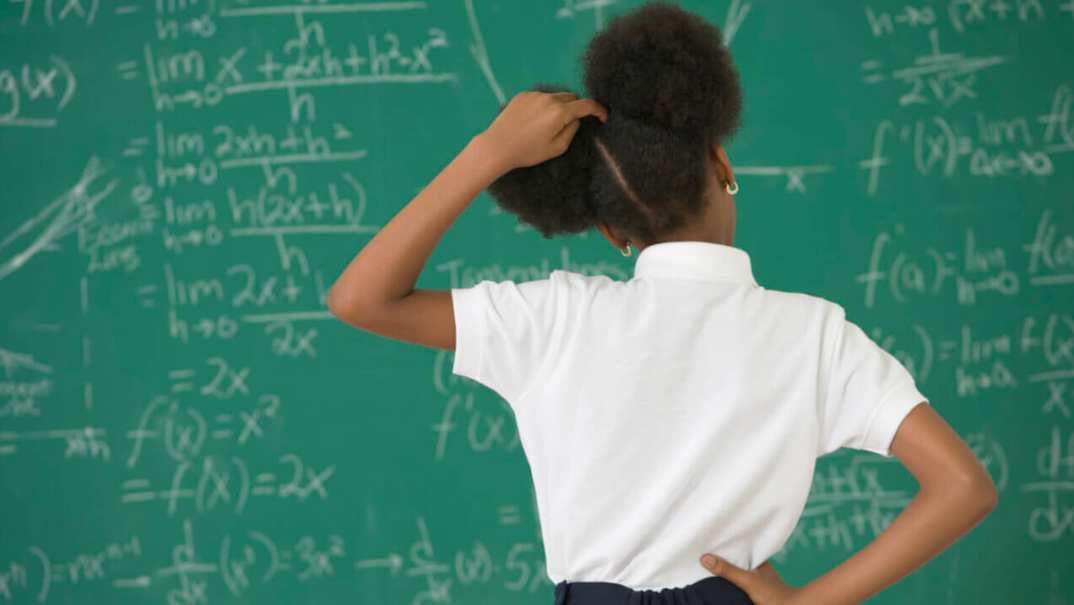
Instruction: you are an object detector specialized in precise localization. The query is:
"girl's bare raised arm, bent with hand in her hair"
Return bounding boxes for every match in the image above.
[328,91,608,350]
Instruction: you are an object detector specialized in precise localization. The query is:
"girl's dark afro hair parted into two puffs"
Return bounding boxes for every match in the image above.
[489,2,742,244]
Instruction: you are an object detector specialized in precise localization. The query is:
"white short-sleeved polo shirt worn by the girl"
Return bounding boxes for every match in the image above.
[451,242,928,590]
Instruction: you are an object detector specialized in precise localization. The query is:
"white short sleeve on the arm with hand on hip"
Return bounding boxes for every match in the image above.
[818,305,928,458]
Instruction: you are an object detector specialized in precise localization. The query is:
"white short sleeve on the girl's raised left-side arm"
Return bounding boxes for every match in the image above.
[451,276,561,404]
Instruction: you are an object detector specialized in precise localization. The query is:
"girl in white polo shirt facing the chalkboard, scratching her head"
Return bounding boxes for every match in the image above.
[328,3,997,605]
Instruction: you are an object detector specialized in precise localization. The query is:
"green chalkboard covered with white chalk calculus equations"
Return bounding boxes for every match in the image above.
[0,0,1074,605]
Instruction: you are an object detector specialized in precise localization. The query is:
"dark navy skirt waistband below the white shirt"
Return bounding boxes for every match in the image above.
[555,576,754,605]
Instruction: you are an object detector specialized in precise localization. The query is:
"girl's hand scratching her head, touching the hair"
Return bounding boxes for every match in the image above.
[478,90,608,172]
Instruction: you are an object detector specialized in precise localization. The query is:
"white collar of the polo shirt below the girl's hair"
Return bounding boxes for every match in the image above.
[634,241,757,286]
